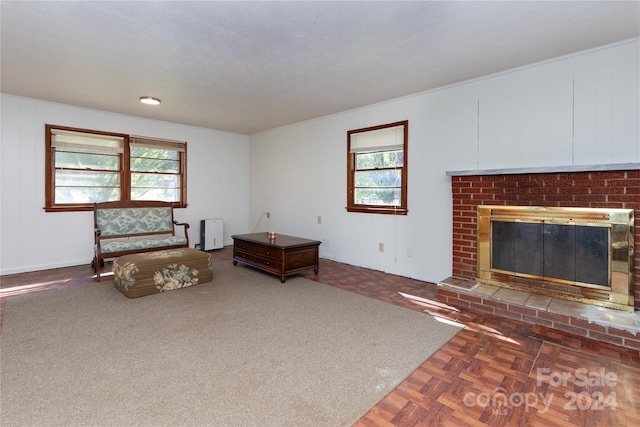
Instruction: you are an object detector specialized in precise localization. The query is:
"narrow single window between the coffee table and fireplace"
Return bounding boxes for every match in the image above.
[347,120,409,215]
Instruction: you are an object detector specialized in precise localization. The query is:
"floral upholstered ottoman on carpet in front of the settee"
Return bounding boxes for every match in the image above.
[113,248,213,298]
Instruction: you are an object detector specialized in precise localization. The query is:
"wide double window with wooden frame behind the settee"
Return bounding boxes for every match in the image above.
[45,125,187,212]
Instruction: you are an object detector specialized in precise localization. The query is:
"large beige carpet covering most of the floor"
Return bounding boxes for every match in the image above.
[0,262,458,427]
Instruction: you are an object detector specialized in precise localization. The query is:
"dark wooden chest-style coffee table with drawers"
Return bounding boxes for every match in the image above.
[231,232,321,283]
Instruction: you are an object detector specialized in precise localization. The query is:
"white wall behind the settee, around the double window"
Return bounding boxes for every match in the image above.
[0,94,249,274]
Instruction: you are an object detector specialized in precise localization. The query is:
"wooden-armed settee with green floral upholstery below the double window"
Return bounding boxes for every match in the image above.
[93,201,189,282]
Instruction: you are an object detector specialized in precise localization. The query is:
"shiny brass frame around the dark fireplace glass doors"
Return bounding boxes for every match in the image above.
[477,206,634,311]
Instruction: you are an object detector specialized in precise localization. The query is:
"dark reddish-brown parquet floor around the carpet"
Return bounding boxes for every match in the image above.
[0,247,640,427]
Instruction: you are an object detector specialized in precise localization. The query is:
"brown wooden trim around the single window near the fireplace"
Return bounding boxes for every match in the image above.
[346,120,409,215]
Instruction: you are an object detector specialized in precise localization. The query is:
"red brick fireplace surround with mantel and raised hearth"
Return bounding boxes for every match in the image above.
[438,163,640,350]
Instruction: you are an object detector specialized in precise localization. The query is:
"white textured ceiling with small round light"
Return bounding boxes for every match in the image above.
[0,1,640,133]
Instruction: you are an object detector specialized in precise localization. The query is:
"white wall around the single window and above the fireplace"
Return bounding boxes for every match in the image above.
[249,39,640,282]
